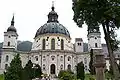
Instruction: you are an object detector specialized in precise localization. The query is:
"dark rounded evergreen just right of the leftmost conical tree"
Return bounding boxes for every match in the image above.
[23,60,35,80]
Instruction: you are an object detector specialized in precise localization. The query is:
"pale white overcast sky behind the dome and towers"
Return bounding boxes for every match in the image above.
[0,0,119,43]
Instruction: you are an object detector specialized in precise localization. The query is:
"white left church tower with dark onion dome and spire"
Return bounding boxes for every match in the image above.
[3,15,18,50]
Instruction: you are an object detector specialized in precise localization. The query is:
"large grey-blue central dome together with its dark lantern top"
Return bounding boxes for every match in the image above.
[35,6,70,37]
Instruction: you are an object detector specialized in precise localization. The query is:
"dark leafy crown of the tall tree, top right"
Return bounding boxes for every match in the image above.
[73,0,120,27]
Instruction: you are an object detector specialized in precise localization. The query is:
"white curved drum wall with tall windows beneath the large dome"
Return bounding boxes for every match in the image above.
[32,34,74,51]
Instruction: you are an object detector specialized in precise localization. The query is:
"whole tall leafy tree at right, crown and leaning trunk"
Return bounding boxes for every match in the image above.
[73,0,120,80]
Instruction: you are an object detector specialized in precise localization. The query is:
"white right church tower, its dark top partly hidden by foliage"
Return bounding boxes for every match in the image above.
[87,26,101,51]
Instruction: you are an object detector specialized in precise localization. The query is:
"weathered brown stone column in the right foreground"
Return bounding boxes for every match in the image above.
[93,49,105,80]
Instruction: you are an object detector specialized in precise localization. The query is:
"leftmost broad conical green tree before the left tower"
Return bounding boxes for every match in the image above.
[4,54,22,80]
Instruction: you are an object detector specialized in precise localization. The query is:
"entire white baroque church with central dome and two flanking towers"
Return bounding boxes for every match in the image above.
[0,6,119,75]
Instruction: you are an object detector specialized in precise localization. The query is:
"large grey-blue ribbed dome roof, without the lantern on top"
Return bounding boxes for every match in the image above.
[35,22,70,37]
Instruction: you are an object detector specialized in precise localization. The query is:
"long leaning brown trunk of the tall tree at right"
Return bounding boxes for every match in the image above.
[102,24,120,80]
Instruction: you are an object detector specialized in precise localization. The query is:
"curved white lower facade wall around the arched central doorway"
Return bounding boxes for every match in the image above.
[31,51,76,75]
